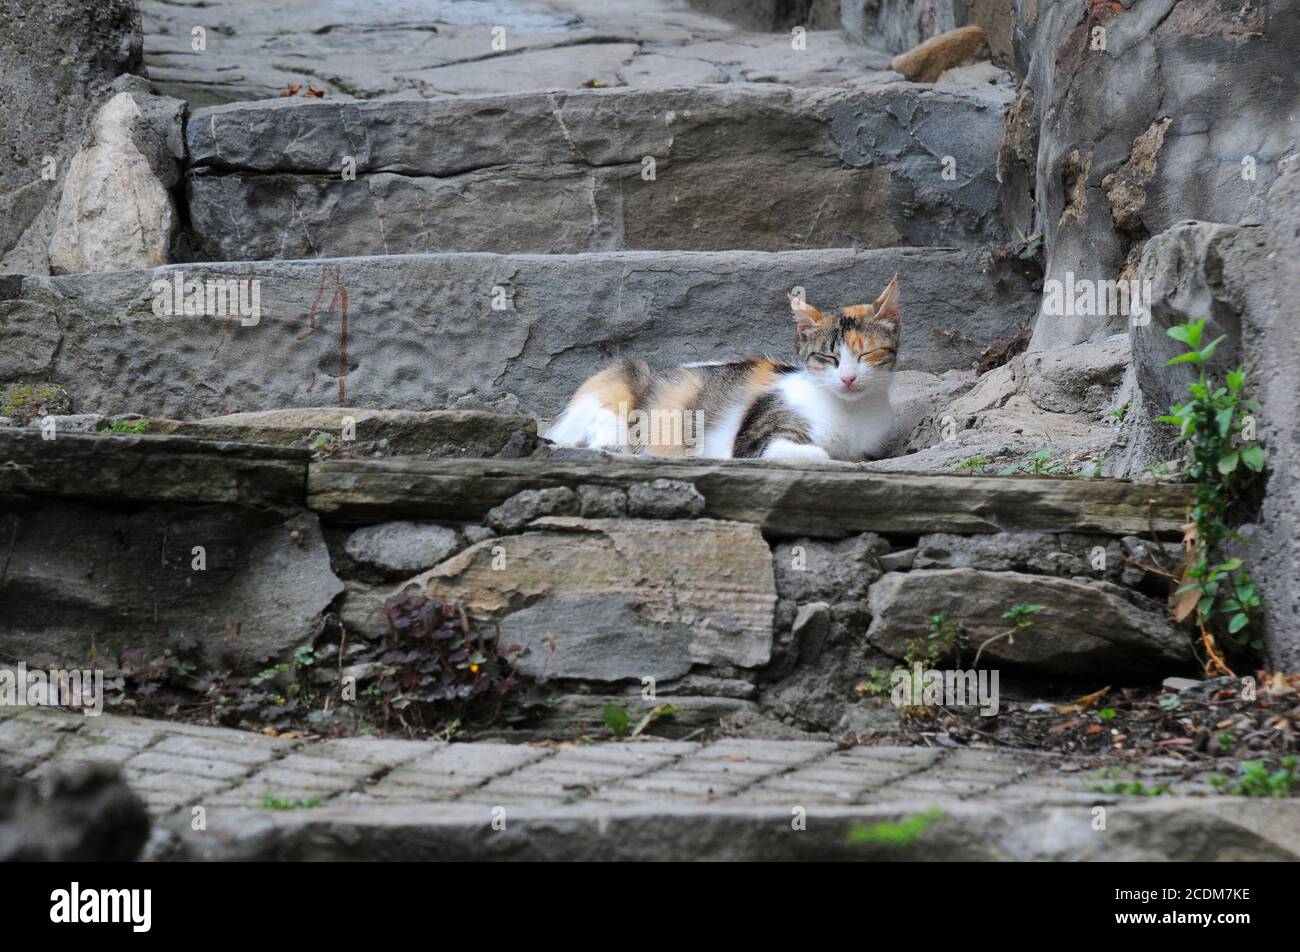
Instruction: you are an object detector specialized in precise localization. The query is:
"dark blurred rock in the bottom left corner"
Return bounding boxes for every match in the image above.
[0,763,150,862]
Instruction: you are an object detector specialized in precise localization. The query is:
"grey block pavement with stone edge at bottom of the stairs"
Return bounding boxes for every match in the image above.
[0,709,1300,860]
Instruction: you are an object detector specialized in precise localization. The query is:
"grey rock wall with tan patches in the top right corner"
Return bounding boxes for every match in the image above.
[1010,0,1300,350]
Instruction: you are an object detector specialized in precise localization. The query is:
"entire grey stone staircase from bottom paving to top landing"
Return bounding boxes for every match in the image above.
[0,0,1300,858]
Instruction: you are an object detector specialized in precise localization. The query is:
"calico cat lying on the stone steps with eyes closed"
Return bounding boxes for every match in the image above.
[546,274,902,460]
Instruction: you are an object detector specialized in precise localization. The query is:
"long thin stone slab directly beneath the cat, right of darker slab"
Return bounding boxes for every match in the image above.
[308,459,1191,537]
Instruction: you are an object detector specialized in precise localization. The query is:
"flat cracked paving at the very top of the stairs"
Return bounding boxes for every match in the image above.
[139,0,889,105]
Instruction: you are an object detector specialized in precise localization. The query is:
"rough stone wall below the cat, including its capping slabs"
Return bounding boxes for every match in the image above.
[0,429,1195,732]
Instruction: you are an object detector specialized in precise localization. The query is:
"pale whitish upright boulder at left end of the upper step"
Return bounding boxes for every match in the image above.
[49,91,185,274]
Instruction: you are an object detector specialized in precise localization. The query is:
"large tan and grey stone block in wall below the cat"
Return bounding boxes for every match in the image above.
[413,516,776,681]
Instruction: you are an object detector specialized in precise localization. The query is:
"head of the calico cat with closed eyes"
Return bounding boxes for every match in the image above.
[790,274,902,401]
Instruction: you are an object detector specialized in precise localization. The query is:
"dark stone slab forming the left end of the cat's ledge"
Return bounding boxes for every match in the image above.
[0,427,311,506]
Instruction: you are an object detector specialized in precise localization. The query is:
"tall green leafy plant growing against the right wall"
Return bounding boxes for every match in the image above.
[1157,320,1264,674]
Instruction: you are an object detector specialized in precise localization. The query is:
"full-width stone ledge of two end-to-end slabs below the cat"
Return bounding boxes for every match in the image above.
[0,428,1192,538]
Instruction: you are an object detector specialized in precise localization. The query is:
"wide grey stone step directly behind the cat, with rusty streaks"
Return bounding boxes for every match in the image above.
[0,248,1037,419]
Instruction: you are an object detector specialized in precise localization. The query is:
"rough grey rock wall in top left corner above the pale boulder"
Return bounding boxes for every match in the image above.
[0,0,140,274]
